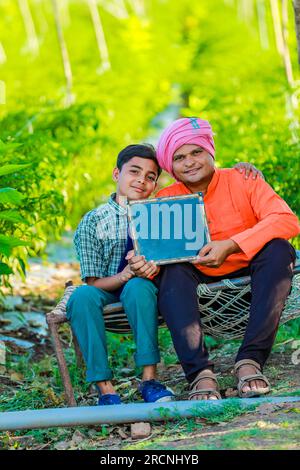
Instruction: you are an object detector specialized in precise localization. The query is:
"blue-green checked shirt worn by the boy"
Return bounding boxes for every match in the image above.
[74,194,128,281]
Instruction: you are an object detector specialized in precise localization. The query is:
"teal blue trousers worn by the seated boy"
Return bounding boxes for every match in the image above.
[67,278,160,382]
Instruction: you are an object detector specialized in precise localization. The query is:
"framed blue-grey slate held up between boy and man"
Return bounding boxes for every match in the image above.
[128,193,210,265]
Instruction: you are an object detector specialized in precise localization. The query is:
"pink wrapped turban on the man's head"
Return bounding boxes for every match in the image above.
[157,118,215,176]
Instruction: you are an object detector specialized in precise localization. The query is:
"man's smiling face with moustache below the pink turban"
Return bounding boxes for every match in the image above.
[173,144,215,189]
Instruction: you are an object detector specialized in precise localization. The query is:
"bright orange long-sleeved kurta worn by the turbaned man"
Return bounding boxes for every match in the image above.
[156,168,300,276]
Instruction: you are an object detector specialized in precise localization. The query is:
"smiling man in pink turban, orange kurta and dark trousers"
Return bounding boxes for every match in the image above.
[130,118,300,399]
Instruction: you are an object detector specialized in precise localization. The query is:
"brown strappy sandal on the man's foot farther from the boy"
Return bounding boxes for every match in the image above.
[234,359,271,398]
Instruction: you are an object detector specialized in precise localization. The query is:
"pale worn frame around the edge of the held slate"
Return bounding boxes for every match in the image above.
[127,193,211,265]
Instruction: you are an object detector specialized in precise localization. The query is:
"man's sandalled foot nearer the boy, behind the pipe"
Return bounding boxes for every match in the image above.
[189,369,221,400]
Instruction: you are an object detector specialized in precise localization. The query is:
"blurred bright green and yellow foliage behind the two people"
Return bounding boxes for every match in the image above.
[0,0,299,277]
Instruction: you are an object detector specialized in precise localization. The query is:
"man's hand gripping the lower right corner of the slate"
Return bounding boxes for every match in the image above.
[191,239,241,268]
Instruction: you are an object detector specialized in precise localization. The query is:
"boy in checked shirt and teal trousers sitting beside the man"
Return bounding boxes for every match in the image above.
[67,145,173,405]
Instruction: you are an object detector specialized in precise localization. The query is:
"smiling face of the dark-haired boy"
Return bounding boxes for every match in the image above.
[113,157,158,203]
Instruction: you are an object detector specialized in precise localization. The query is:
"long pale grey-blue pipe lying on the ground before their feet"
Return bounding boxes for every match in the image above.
[0,397,300,431]
